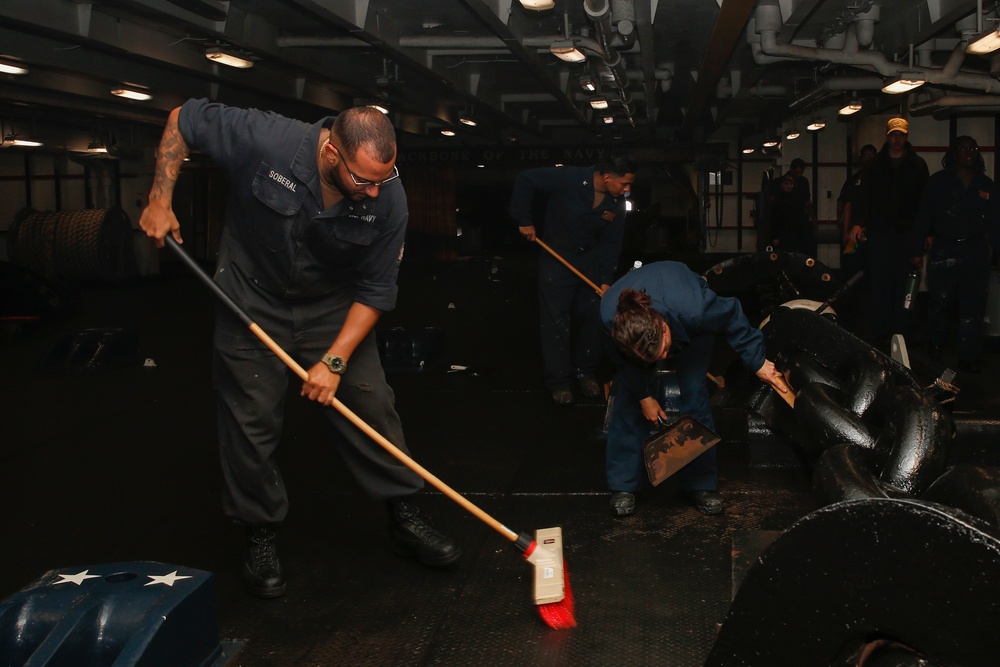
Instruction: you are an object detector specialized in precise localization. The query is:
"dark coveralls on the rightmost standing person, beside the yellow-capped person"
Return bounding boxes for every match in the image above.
[911,169,1000,363]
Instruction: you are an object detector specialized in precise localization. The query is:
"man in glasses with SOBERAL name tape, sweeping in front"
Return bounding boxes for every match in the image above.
[140,99,460,598]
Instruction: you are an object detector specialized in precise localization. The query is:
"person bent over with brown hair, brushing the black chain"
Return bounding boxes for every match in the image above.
[601,262,789,517]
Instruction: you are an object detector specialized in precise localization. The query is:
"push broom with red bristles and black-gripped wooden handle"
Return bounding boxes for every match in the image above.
[166,234,576,630]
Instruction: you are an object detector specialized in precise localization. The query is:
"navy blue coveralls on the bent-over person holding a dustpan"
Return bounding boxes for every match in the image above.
[601,262,765,493]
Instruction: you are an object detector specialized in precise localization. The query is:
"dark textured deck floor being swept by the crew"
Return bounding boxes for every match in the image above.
[0,252,1000,667]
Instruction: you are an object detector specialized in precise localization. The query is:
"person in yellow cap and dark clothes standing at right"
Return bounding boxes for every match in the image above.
[848,118,929,352]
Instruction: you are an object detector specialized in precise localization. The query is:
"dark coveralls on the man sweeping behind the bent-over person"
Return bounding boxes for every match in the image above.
[509,166,625,391]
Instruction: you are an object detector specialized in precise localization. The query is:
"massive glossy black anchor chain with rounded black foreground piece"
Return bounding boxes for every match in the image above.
[705,307,1000,667]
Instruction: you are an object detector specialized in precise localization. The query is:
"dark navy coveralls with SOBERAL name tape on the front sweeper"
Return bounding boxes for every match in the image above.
[178,100,423,525]
